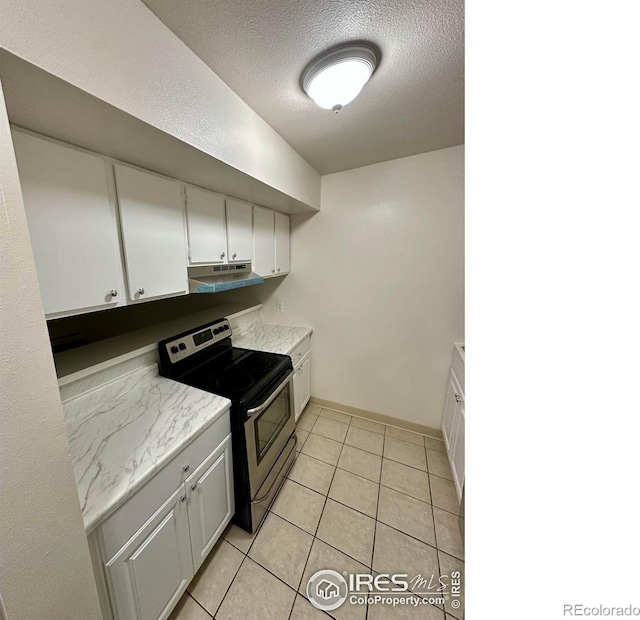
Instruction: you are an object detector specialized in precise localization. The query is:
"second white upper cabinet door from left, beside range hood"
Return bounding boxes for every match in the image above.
[115,164,189,301]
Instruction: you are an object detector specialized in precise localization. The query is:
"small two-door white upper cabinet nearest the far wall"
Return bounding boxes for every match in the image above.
[253,206,291,278]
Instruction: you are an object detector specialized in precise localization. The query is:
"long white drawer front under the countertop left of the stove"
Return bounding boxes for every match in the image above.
[101,411,231,561]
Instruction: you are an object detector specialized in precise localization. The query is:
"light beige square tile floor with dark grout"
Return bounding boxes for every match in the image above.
[170,405,464,620]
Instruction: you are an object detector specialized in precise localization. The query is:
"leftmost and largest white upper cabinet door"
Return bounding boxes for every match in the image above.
[12,131,126,317]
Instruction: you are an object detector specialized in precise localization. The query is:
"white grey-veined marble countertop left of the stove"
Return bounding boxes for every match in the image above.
[63,364,231,532]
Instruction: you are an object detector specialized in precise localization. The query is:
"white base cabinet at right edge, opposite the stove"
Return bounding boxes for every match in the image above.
[442,345,465,500]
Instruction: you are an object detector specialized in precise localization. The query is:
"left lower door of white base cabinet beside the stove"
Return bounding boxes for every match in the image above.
[106,486,194,620]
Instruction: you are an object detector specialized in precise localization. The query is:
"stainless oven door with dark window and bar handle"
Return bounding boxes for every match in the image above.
[245,372,295,499]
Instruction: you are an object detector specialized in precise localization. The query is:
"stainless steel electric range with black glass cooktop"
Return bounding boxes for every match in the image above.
[159,319,296,533]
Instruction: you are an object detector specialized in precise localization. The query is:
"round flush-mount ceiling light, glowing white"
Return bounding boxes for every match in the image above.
[302,43,379,114]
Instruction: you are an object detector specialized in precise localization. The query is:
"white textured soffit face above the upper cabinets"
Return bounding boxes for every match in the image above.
[0,0,320,208]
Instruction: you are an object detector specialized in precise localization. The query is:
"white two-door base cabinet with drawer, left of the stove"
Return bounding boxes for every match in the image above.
[94,411,235,620]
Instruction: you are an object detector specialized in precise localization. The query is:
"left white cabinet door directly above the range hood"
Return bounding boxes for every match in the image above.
[185,187,227,265]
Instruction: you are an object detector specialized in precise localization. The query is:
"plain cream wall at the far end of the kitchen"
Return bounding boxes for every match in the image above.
[265,146,464,428]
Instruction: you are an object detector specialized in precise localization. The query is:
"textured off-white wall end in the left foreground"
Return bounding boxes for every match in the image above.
[0,82,100,620]
